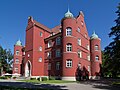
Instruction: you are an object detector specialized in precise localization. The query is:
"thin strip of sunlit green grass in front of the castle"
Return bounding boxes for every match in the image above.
[20,80,75,84]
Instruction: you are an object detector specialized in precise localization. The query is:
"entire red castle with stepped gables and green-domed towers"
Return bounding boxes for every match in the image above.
[13,9,102,80]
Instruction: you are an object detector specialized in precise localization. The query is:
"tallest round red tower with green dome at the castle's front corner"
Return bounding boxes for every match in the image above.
[61,9,77,80]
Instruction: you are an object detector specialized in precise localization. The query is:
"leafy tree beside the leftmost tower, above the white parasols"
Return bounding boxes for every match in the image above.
[0,46,13,74]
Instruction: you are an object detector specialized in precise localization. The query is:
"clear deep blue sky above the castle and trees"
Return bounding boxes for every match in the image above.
[0,0,119,52]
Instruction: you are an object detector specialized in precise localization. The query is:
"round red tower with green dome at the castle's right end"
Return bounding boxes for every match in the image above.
[90,32,102,79]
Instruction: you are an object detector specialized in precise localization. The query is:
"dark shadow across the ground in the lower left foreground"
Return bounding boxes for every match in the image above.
[0,82,68,90]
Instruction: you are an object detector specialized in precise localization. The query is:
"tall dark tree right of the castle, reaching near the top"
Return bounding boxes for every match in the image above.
[103,3,120,77]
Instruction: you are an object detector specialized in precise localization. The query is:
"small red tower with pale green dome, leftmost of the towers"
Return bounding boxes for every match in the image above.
[13,40,22,76]
